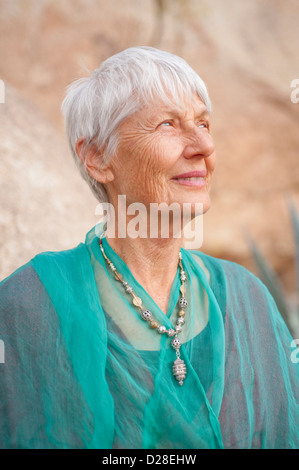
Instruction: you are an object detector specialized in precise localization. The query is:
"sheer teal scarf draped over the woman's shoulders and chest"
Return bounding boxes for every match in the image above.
[0,229,299,449]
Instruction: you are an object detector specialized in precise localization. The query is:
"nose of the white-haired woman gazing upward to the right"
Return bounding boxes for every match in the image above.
[184,128,215,159]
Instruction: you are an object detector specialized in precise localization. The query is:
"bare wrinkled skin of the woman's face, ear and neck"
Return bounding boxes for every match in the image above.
[77,92,216,313]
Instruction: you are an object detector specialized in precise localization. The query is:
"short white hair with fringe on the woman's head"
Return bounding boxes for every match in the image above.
[62,46,211,202]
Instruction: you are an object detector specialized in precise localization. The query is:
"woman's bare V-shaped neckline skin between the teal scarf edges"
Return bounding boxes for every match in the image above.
[106,234,182,314]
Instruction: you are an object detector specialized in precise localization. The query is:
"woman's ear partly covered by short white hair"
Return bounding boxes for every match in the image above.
[76,137,114,184]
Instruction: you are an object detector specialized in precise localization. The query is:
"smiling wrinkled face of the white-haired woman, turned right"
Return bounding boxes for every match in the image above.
[106,96,215,217]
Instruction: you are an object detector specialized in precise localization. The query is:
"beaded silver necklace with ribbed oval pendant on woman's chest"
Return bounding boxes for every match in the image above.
[99,233,188,385]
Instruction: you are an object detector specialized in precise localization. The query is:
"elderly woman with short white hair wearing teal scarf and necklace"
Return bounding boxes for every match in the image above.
[0,47,299,449]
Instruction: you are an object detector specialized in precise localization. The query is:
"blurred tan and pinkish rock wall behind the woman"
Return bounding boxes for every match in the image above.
[0,0,299,298]
